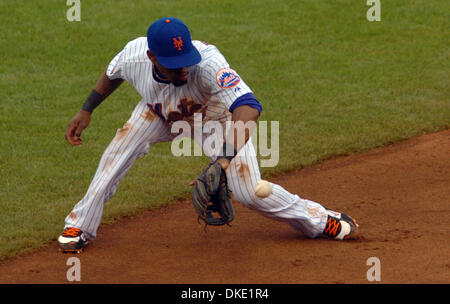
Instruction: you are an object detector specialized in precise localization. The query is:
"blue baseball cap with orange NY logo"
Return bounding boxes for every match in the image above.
[147,17,202,69]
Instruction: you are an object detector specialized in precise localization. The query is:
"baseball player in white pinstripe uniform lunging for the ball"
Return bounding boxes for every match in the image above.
[58,17,358,251]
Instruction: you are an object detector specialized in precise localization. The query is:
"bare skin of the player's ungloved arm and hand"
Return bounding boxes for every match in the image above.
[66,71,123,146]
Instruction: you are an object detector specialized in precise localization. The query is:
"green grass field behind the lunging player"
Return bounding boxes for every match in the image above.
[0,0,450,259]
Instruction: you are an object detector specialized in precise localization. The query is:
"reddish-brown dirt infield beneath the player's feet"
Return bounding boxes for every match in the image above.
[0,130,450,284]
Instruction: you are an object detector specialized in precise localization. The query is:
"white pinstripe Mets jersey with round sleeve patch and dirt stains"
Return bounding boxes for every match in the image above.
[106,37,252,123]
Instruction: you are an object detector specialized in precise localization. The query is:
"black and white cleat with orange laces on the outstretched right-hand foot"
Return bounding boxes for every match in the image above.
[323,210,359,240]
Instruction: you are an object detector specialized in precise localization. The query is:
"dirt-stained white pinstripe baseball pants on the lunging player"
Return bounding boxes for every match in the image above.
[65,101,327,239]
